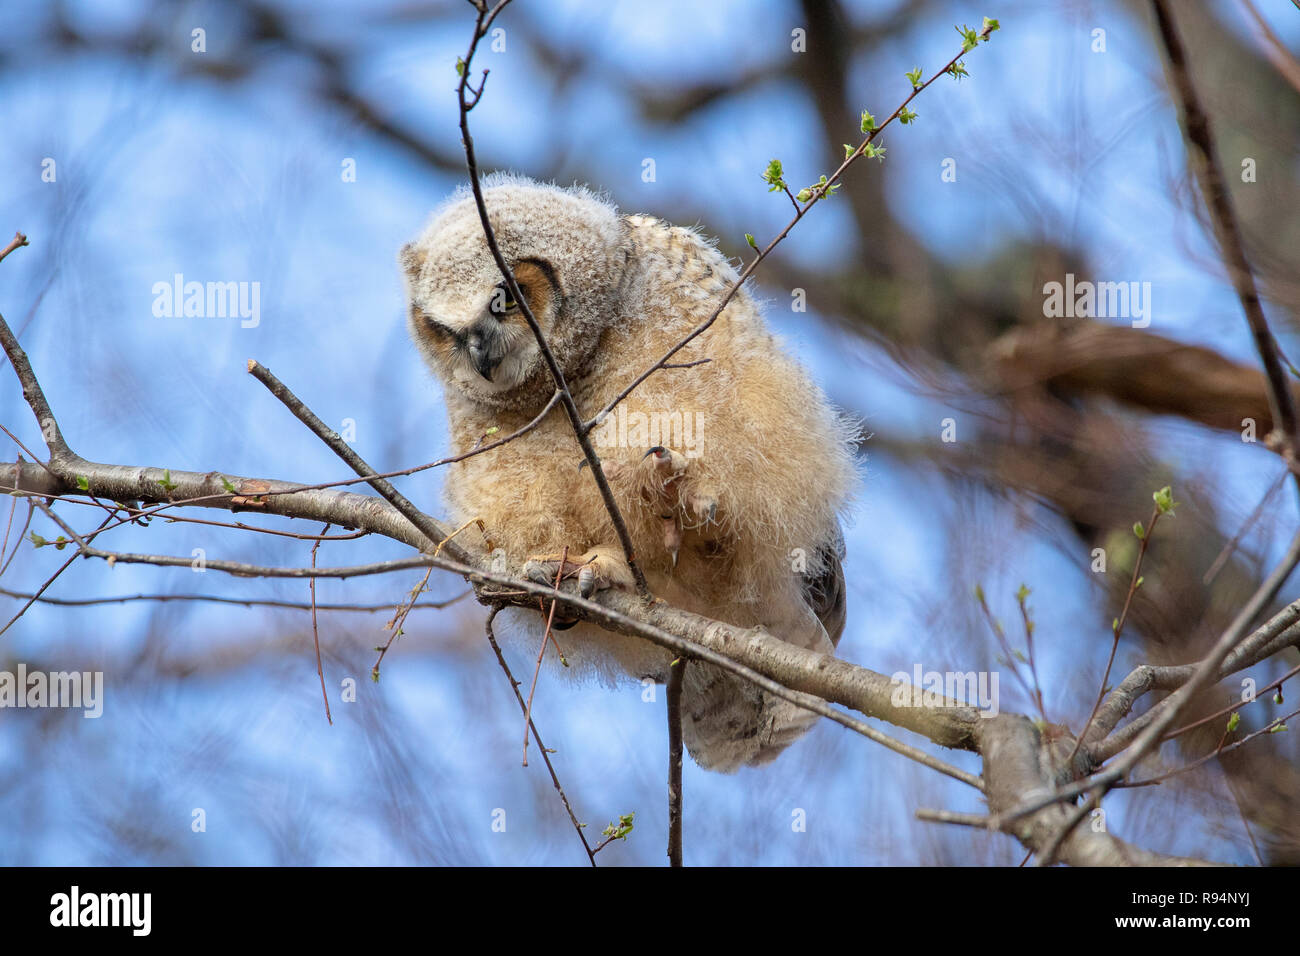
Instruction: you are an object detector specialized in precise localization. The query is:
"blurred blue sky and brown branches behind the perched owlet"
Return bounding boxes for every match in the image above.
[0,0,1300,865]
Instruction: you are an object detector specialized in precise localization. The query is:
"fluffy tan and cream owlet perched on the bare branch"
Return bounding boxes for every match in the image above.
[399,176,858,773]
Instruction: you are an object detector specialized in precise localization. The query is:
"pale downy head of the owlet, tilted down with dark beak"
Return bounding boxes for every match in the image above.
[399,176,628,407]
